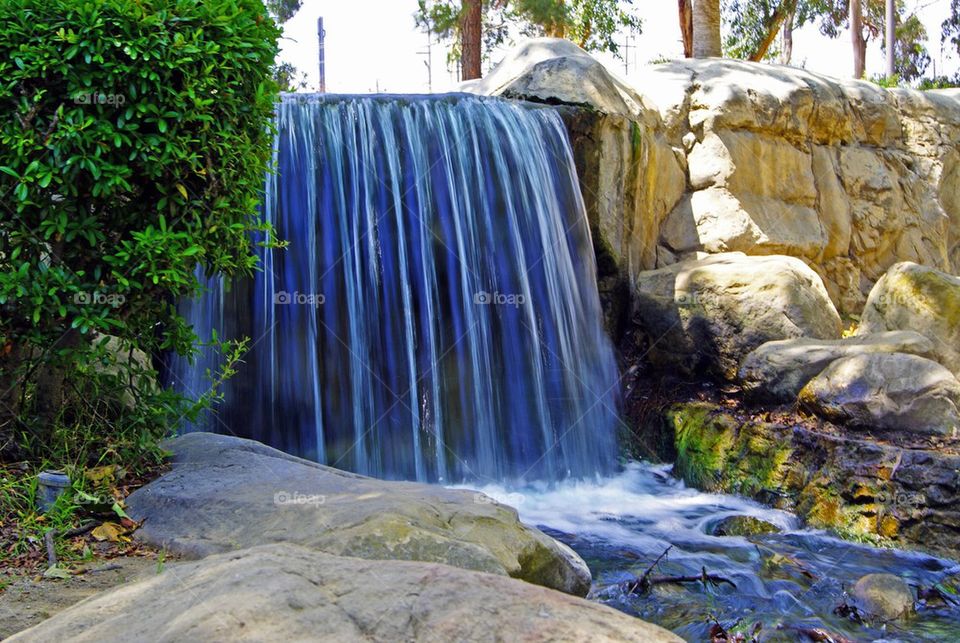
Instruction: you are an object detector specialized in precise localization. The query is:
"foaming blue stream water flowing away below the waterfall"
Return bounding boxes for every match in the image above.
[460,463,960,641]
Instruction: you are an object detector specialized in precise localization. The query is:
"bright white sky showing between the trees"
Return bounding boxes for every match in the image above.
[281,0,960,93]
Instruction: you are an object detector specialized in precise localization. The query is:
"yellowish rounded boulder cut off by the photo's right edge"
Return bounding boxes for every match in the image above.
[857,262,960,375]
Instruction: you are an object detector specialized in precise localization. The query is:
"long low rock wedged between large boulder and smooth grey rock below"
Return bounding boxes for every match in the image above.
[737,330,934,402]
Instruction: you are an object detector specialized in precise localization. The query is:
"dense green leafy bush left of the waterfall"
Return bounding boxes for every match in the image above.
[0,0,279,466]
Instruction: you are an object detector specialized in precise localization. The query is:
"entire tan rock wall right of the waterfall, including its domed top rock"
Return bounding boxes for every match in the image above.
[466,39,960,316]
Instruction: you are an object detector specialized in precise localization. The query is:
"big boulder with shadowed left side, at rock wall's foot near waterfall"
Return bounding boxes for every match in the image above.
[633,252,841,379]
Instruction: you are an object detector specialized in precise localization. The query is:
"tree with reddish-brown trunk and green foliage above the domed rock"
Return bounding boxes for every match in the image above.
[414,0,640,79]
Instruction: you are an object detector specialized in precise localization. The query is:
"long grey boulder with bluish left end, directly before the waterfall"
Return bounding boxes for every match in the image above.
[127,433,591,596]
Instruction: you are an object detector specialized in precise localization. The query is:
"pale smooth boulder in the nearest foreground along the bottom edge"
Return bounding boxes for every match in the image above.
[8,544,682,643]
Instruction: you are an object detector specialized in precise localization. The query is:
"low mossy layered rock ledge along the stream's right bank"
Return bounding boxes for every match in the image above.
[663,402,960,558]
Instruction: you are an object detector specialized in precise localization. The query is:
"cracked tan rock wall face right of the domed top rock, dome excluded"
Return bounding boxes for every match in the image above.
[629,60,960,313]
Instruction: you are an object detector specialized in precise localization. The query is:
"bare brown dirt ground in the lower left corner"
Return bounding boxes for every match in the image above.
[0,555,172,640]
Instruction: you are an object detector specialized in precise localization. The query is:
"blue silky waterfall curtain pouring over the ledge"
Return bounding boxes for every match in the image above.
[170,95,618,482]
